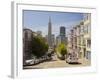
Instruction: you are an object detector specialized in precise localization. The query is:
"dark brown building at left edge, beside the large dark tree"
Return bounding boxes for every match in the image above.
[23,28,33,65]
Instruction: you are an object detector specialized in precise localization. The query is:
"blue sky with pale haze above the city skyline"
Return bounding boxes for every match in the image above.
[23,10,83,36]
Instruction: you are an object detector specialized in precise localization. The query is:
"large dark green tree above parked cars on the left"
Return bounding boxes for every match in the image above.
[32,36,48,57]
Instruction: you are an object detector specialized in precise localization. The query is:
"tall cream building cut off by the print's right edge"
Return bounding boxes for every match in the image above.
[84,14,91,59]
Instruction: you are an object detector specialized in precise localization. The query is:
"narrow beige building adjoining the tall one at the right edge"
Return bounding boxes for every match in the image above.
[77,21,86,58]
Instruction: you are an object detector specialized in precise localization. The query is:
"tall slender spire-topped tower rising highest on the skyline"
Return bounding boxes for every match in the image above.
[48,17,52,47]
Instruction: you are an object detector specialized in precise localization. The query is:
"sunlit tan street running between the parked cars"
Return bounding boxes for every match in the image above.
[24,55,90,69]
